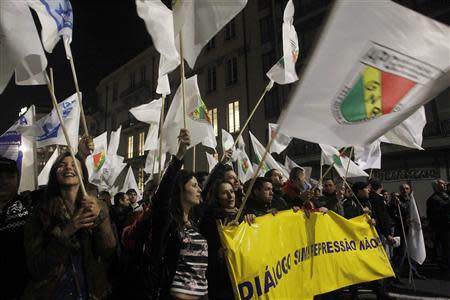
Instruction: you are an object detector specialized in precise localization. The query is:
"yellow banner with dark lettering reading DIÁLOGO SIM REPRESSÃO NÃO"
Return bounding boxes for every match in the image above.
[219,211,394,300]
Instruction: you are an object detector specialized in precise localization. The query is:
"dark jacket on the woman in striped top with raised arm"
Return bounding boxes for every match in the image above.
[145,156,183,299]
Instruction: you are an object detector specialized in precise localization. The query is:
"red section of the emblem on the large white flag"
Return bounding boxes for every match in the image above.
[381,71,416,114]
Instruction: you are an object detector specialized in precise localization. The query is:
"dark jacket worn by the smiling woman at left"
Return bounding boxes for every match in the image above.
[24,193,115,299]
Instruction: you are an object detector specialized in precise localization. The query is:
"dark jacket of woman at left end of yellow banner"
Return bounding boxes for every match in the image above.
[199,203,237,300]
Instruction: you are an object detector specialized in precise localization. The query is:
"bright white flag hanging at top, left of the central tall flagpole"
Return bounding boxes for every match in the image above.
[136,0,180,75]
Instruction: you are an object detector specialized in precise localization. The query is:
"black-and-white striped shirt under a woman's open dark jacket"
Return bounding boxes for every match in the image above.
[170,225,208,296]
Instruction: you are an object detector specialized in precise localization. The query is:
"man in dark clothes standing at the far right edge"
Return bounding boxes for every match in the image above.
[427,179,450,270]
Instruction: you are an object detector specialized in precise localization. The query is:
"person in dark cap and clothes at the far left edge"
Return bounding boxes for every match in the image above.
[0,156,31,299]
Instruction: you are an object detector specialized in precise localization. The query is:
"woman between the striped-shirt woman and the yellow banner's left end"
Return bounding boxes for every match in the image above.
[199,181,238,300]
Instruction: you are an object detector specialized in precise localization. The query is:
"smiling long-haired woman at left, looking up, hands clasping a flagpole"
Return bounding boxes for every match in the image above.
[24,152,116,300]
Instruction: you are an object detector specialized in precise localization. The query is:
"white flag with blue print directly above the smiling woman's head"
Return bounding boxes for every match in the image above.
[36,94,80,153]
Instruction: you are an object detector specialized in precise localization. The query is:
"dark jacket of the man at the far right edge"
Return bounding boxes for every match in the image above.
[427,193,450,230]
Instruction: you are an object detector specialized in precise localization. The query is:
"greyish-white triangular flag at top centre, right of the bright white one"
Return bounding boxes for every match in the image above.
[172,0,247,69]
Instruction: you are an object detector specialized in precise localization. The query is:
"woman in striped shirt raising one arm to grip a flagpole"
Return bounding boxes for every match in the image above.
[147,129,208,300]
